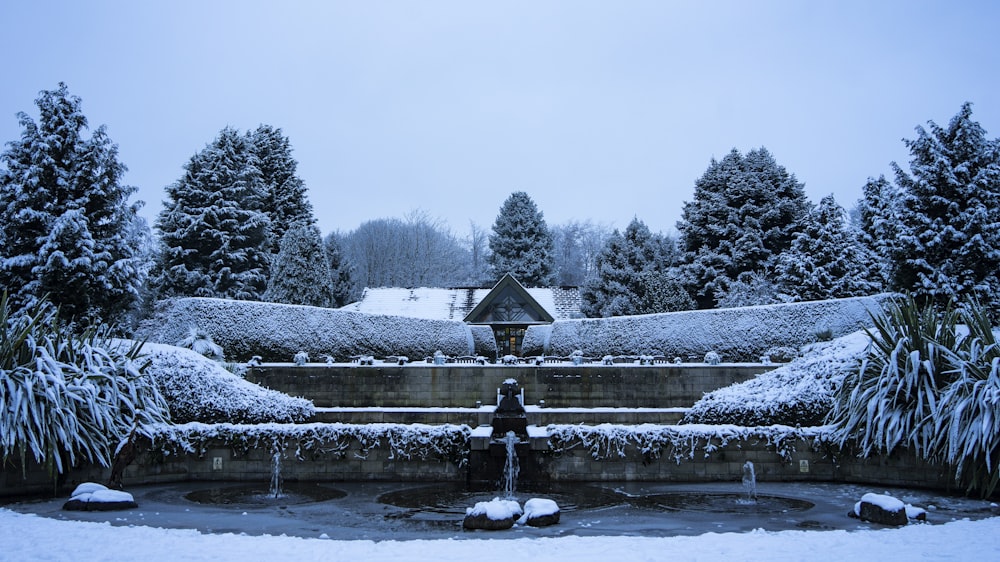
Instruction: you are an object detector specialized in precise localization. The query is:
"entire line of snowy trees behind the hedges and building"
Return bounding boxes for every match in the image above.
[0,83,1000,324]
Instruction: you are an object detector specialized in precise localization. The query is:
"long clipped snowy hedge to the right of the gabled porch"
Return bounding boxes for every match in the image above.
[523,294,891,362]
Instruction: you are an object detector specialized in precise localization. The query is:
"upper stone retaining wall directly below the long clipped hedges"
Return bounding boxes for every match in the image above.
[246,363,775,408]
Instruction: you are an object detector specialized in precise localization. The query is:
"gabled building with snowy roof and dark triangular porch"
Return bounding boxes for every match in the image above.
[342,273,583,355]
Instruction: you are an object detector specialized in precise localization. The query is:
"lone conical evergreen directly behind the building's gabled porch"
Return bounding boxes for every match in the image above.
[487,191,555,287]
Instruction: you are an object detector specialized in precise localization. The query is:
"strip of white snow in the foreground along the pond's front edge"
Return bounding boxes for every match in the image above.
[0,509,1000,562]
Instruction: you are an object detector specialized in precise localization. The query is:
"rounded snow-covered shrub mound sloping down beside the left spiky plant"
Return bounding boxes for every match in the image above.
[142,344,314,423]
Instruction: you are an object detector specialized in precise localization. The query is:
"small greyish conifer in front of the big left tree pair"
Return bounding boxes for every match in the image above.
[263,224,336,308]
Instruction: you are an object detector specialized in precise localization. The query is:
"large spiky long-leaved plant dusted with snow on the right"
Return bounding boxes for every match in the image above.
[829,296,1000,496]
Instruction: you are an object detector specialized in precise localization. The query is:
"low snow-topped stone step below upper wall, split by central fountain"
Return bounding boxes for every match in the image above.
[309,405,688,427]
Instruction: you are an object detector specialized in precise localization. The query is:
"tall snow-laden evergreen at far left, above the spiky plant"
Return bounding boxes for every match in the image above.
[0,83,146,323]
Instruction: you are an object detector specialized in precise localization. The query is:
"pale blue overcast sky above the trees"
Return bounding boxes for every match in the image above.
[0,0,1000,236]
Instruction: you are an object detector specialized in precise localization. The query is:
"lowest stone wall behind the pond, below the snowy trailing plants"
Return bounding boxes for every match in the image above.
[0,428,954,497]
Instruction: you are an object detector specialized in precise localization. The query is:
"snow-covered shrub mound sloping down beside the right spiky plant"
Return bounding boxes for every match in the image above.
[681,331,871,427]
